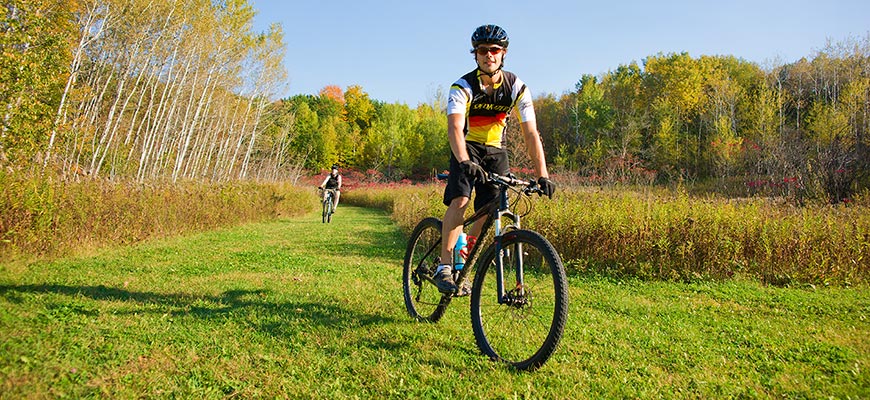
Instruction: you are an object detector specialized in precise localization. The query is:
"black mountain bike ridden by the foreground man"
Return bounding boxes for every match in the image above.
[402,170,568,370]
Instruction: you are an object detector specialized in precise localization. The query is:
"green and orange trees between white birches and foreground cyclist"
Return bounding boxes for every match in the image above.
[265,85,450,179]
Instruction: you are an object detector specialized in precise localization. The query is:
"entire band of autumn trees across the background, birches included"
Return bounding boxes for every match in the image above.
[0,0,870,202]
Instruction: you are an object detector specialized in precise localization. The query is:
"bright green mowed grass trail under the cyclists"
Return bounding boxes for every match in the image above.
[0,206,870,399]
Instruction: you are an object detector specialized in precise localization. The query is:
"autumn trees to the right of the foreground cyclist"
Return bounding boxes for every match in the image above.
[535,43,870,203]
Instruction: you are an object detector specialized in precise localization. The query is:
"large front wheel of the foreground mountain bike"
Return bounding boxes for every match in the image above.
[471,230,568,370]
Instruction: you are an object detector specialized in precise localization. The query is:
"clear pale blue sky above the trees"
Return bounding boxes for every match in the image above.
[251,0,870,107]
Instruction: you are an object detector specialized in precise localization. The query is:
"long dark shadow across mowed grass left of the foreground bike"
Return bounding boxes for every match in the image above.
[0,284,410,350]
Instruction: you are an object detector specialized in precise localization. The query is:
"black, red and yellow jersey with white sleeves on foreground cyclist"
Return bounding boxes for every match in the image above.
[447,70,535,147]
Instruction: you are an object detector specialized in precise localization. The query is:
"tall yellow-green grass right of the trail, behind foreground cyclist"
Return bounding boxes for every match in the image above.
[343,185,870,286]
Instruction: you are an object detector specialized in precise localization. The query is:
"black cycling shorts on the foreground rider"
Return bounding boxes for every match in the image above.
[444,142,510,211]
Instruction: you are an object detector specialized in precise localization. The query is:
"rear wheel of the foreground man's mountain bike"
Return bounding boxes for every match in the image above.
[402,217,451,322]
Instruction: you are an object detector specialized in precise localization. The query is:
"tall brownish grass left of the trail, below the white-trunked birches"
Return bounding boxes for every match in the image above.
[0,172,317,258]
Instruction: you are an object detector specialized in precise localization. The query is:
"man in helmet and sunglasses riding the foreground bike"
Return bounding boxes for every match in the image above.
[434,25,555,293]
